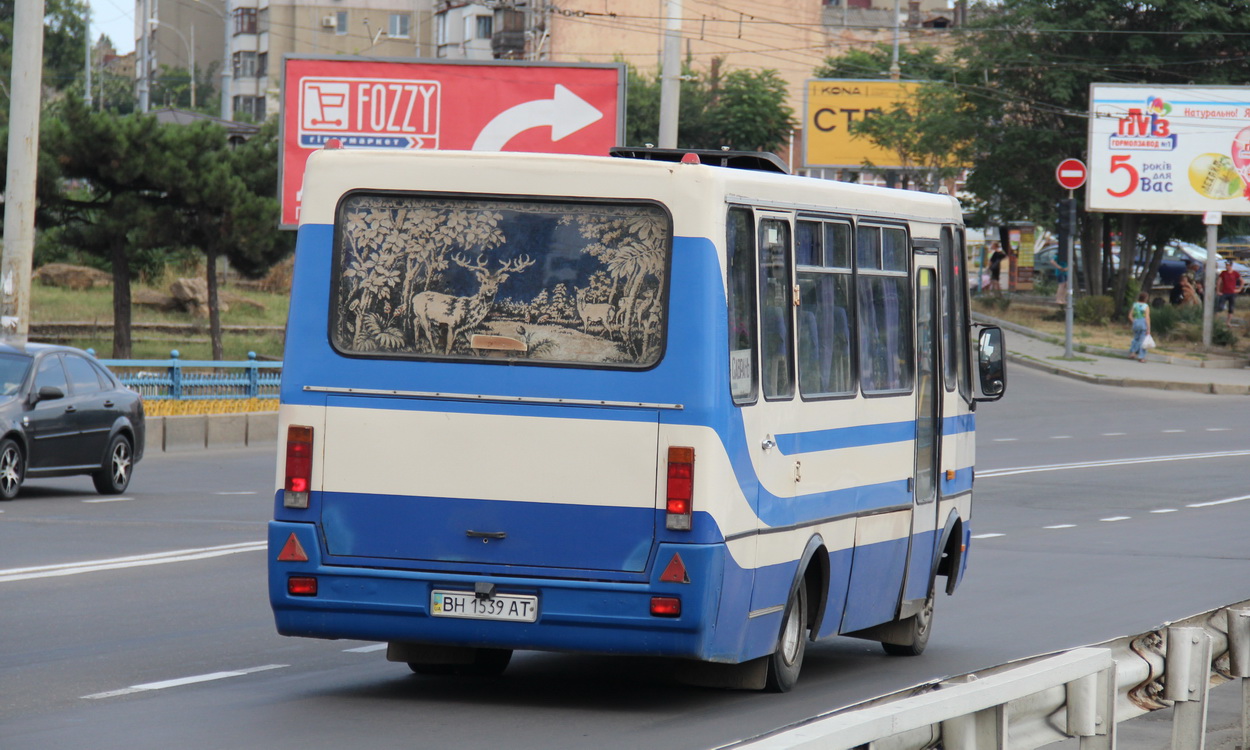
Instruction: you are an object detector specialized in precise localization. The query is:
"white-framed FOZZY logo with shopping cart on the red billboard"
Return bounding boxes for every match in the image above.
[299,78,441,149]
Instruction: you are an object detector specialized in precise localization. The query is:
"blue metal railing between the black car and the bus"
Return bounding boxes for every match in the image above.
[93,349,283,400]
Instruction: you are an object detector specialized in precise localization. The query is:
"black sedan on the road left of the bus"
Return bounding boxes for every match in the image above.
[0,344,144,500]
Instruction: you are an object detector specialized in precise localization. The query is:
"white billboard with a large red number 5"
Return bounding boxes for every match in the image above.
[1085,84,1250,214]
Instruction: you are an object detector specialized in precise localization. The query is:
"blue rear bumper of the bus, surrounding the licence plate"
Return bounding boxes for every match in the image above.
[269,521,750,661]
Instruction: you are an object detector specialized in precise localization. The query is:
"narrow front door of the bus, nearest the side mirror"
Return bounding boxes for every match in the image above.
[901,268,941,602]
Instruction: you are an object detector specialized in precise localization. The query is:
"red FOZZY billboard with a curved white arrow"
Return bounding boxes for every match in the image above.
[279,56,625,228]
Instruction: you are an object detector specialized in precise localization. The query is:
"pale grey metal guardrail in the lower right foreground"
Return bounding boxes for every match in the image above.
[720,601,1250,750]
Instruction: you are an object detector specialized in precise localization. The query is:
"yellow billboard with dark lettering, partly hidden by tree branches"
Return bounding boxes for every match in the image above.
[804,79,919,168]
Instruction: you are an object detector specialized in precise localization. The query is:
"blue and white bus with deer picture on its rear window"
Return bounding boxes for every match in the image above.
[269,149,1005,691]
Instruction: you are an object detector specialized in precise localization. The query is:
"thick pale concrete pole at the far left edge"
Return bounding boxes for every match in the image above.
[0,0,44,344]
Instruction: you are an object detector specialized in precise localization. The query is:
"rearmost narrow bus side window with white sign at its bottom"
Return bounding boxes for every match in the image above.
[725,209,758,404]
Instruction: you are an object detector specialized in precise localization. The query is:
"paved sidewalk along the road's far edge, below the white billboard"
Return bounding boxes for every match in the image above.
[973,314,1250,396]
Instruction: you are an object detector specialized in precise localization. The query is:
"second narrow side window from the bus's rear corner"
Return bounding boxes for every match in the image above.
[760,219,794,399]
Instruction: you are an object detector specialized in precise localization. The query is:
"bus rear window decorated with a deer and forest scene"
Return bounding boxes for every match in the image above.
[330,194,673,368]
